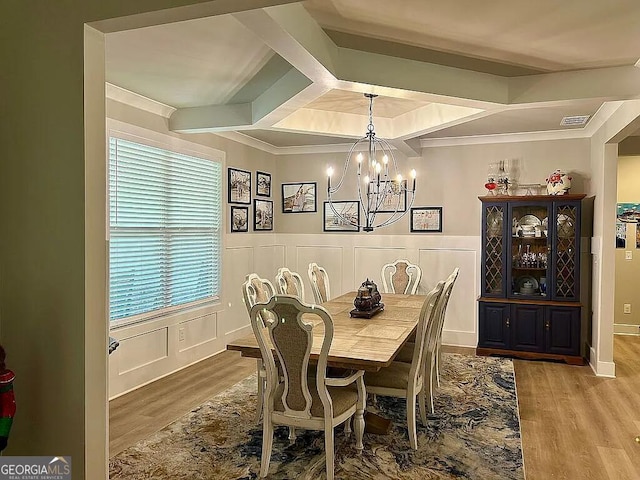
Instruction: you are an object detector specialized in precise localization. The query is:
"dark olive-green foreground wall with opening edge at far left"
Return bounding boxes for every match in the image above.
[0,0,292,479]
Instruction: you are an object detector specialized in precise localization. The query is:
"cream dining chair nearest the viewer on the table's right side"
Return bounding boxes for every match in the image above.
[364,282,444,450]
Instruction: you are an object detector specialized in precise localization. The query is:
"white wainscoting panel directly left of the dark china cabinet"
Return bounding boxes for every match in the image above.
[418,249,478,346]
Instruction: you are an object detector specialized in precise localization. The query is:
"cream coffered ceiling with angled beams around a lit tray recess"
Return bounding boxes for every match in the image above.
[106,0,640,156]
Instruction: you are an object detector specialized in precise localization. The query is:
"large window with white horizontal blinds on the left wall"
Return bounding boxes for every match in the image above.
[109,137,222,321]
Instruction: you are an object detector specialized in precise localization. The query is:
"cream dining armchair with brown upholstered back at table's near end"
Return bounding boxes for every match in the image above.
[250,295,366,480]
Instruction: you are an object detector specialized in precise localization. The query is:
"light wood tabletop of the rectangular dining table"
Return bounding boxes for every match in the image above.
[227,292,426,372]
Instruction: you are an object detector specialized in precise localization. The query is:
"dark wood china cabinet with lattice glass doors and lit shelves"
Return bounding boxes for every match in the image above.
[477,194,593,364]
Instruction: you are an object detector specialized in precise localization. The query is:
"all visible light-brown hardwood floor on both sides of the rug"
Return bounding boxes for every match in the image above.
[109,336,640,480]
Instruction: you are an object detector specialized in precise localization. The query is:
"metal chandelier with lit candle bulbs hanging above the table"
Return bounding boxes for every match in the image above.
[327,93,416,232]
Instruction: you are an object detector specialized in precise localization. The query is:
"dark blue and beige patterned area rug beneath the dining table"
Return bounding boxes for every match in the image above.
[109,354,524,480]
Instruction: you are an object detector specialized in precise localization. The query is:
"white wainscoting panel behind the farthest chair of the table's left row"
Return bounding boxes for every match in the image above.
[296,245,344,303]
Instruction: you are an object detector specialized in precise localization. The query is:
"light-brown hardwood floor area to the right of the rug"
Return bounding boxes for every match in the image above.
[514,336,640,480]
